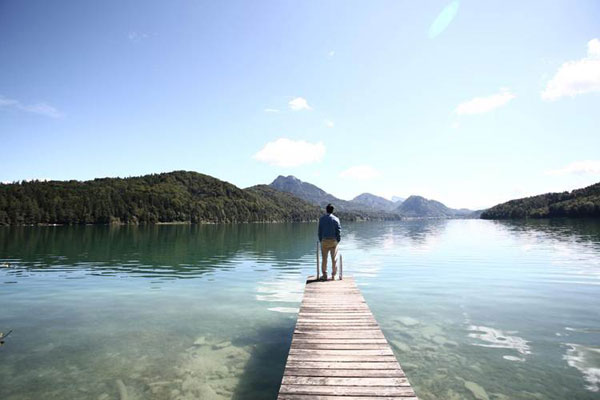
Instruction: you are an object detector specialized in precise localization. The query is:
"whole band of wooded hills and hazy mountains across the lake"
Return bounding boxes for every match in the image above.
[0,171,600,225]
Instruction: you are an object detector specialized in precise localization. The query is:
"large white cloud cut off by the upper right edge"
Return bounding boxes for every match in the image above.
[541,39,600,101]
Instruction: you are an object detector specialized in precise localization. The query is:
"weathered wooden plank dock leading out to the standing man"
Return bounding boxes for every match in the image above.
[278,277,417,400]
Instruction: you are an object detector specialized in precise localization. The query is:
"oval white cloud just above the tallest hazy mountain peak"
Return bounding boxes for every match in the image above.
[253,138,325,167]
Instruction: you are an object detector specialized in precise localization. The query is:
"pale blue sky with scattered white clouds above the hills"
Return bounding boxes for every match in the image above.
[0,1,600,208]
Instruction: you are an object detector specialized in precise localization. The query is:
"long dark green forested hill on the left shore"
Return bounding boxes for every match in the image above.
[0,171,321,225]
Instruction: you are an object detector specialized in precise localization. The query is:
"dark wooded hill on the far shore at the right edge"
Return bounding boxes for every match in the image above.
[481,182,600,219]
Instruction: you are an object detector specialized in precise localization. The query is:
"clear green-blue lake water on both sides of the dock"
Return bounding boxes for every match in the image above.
[0,220,600,400]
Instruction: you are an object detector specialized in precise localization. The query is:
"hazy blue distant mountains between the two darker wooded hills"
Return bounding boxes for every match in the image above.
[270,175,479,219]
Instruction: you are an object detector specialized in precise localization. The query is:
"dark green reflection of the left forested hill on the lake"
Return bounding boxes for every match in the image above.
[0,223,316,277]
